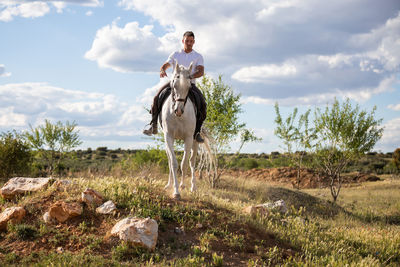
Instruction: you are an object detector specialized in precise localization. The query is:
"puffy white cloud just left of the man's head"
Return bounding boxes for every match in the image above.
[85,21,167,72]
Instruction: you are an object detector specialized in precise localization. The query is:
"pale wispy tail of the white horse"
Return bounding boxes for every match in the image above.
[198,127,220,187]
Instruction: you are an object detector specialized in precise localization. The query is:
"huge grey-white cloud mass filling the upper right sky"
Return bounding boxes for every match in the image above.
[113,0,400,107]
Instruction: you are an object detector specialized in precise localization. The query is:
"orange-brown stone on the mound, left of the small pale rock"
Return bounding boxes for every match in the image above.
[48,201,83,223]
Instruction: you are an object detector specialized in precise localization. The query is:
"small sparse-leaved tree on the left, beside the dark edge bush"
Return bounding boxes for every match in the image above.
[25,120,82,175]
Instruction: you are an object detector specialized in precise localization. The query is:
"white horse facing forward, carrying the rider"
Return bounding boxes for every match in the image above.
[160,63,198,199]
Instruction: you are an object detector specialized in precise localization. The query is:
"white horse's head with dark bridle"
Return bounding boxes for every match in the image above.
[171,63,193,117]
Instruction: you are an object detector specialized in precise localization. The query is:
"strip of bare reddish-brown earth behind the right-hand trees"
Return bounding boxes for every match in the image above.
[224,167,380,188]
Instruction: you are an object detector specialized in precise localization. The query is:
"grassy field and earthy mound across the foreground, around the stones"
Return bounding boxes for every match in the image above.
[0,165,400,266]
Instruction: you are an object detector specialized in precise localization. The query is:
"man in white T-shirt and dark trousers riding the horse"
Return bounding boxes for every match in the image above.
[143,31,207,143]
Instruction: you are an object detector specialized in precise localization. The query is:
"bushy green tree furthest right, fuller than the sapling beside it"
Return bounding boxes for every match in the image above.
[314,99,383,201]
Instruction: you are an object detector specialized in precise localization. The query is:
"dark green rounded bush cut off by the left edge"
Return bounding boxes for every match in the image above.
[0,131,32,178]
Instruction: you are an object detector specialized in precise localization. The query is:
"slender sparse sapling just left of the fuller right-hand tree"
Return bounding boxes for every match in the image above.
[274,103,316,189]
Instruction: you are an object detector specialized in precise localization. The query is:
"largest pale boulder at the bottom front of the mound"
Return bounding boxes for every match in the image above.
[111,217,158,250]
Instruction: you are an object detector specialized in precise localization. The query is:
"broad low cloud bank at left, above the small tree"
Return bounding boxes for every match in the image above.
[0,83,150,140]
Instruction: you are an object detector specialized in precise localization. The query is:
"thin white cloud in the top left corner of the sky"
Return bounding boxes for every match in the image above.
[0,0,103,22]
